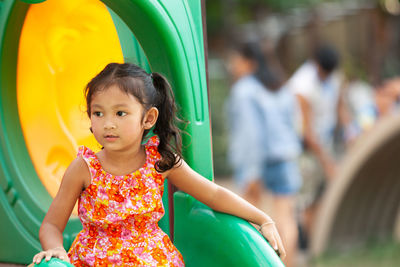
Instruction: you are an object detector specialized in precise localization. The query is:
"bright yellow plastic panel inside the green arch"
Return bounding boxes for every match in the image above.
[17,0,123,197]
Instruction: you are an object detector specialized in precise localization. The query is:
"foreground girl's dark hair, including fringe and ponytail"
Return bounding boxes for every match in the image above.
[85,63,182,172]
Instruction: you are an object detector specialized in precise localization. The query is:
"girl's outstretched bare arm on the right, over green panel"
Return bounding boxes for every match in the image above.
[164,160,286,258]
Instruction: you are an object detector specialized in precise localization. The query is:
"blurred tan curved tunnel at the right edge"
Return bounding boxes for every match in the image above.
[311,115,400,256]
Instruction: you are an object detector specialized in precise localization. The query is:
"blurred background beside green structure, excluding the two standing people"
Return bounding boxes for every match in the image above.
[205,0,400,266]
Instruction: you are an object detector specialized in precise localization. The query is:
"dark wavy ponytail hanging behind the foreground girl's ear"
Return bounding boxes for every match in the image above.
[150,72,182,172]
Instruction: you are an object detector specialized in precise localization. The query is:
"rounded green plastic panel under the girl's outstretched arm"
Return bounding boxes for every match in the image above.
[174,192,283,267]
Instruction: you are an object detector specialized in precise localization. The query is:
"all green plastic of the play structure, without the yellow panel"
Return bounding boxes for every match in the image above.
[0,0,283,266]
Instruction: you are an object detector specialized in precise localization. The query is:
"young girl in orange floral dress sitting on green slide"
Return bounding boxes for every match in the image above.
[33,63,285,266]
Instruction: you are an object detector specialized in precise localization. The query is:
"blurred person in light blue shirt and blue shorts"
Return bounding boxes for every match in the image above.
[227,42,302,267]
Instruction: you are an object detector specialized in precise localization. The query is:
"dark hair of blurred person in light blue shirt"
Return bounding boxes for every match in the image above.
[235,42,282,91]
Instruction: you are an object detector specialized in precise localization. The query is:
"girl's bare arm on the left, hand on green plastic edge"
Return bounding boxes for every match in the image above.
[33,157,90,263]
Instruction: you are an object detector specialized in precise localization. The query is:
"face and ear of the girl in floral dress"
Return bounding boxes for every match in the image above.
[90,85,158,151]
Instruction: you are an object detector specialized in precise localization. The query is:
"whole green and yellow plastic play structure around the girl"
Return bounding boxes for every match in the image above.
[0,0,282,266]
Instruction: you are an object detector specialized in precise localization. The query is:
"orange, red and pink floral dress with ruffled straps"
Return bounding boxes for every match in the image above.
[68,136,184,266]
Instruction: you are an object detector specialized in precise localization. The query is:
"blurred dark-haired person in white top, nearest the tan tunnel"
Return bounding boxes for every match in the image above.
[286,45,349,251]
